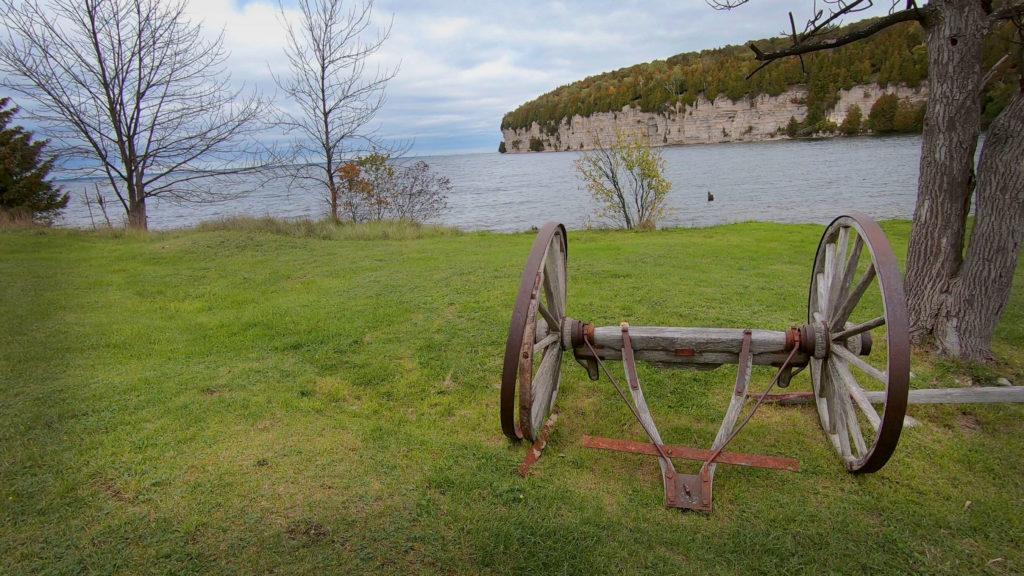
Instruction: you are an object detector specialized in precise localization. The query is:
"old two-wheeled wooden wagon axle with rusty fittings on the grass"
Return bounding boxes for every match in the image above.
[501,214,1024,511]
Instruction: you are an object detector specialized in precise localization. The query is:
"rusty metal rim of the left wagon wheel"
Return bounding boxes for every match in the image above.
[501,222,568,441]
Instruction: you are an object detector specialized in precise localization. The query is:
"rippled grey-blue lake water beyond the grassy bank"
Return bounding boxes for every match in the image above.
[61,136,921,232]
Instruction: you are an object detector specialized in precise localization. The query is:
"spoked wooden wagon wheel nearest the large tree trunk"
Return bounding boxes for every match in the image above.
[807,213,910,472]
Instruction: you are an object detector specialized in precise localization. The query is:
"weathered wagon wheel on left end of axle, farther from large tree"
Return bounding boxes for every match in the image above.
[501,222,568,441]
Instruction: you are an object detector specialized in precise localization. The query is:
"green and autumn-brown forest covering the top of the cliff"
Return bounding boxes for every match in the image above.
[502,19,1019,133]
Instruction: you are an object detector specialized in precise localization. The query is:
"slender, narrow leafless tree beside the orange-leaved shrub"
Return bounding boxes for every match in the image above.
[274,0,397,220]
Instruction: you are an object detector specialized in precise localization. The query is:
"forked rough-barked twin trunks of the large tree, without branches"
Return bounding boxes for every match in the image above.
[905,0,1024,360]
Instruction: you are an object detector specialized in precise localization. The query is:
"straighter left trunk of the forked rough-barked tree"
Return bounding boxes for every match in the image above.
[905,0,988,343]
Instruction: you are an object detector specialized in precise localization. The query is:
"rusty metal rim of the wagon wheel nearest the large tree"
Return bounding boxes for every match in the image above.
[807,212,910,472]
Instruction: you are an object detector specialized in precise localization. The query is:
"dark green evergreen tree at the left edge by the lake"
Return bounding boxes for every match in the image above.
[0,97,69,223]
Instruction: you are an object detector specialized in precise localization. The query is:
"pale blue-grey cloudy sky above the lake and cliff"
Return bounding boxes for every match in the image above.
[16,0,897,155]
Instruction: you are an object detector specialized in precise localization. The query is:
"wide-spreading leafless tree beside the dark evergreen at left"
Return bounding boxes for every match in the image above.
[0,0,268,229]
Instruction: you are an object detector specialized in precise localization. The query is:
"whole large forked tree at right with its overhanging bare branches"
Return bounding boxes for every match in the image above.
[710,0,1024,360]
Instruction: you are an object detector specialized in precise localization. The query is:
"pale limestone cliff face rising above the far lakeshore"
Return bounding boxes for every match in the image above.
[502,84,927,153]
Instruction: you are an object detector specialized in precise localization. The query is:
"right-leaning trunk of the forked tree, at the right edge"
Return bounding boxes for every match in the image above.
[934,91,1024,360]
